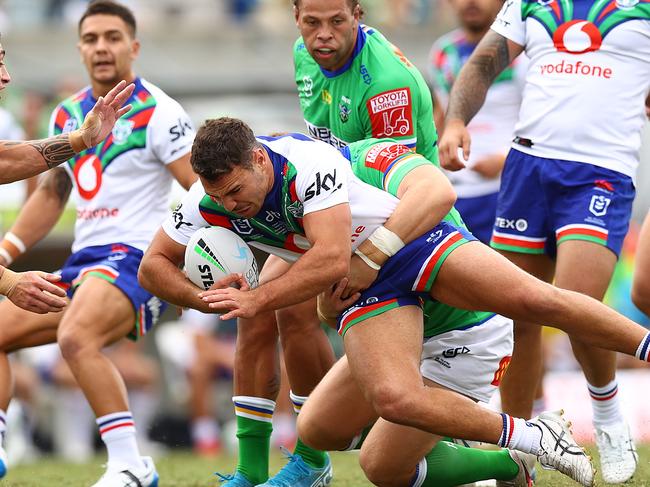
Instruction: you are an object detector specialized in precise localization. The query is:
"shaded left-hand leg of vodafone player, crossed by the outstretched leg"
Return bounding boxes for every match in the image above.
[499,251,555,418]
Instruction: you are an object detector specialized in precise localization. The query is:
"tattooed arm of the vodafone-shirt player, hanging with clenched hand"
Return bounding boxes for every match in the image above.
[440,30,523,170]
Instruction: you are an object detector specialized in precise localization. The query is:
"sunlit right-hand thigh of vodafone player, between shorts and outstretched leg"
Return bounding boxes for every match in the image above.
[555,240,616,300]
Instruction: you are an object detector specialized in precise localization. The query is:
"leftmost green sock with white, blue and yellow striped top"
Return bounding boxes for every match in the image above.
[233,396,275,485]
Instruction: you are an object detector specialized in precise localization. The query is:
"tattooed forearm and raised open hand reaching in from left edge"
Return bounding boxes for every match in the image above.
[0,81,134,184]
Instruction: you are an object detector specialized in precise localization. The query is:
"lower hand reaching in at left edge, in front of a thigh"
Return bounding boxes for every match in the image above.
[5,270,67,314]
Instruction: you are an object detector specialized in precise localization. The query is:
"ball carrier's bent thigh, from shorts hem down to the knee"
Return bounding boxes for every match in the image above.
[343,306,423,406]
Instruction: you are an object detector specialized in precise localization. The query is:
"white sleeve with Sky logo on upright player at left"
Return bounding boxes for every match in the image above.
[143,81,195,164]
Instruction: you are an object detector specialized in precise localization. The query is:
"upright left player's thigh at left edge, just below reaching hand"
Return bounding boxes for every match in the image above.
[0,299,61,352]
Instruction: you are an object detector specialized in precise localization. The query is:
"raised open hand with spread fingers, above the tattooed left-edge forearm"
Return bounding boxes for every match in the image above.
[79,80,135,148]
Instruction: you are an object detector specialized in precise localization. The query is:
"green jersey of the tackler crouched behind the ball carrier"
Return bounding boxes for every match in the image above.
[341,139,494,337]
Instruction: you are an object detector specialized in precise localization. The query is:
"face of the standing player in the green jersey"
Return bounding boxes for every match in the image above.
[294,0,359,71]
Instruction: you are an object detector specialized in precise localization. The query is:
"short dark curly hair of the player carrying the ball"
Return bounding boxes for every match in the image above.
[190,117,260,181]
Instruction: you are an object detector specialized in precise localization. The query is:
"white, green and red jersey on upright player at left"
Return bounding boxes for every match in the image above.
[50,78,194,252]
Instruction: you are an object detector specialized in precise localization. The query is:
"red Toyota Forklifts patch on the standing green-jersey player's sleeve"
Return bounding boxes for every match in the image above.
[366,87,413,137]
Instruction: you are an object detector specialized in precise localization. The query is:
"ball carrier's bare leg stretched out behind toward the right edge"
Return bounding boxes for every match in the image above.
[431,242,648,358]
